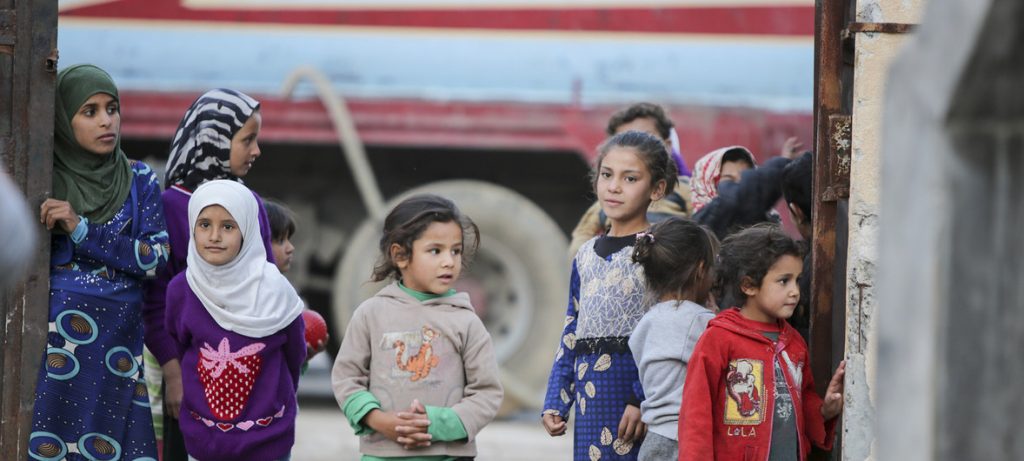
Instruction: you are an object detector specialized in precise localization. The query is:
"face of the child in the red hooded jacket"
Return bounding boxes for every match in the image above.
[741,254,804,323]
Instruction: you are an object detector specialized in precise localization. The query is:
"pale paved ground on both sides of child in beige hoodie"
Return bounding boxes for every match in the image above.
[292,354,572,461]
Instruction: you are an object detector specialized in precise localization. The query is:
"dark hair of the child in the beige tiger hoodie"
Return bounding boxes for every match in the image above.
[371,194,480,282]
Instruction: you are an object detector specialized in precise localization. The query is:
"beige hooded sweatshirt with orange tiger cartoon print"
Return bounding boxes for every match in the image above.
[331,283,504,457]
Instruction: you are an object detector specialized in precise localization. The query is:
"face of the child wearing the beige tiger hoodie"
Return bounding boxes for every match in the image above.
[391,222,462,294]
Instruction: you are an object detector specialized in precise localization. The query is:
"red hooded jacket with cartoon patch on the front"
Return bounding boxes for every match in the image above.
[679,308,839,461]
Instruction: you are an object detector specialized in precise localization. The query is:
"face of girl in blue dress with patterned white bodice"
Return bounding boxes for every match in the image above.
[596,148,665,231]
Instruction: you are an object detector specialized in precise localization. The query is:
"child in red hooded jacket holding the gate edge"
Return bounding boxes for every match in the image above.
[679,224,845,461]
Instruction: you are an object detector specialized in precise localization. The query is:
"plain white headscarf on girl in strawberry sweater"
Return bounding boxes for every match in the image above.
[185,179,302,338]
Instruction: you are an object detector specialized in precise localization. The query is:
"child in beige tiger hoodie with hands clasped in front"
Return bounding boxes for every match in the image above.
[332,195,503,461]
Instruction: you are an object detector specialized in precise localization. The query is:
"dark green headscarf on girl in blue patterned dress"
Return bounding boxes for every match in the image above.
[53,65,132,223]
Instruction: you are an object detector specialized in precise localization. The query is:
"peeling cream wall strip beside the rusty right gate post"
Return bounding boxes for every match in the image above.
[843,0,925,461]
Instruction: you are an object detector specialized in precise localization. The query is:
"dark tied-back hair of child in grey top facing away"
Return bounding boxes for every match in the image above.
[633,216,718,304]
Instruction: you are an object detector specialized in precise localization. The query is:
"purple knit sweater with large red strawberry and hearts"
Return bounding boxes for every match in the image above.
[166,274,306,461]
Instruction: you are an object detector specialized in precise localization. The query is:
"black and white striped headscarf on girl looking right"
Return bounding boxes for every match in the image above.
[164,89,259,191]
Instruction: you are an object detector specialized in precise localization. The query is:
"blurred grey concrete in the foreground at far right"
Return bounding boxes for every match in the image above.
[877,0,1024,461]
